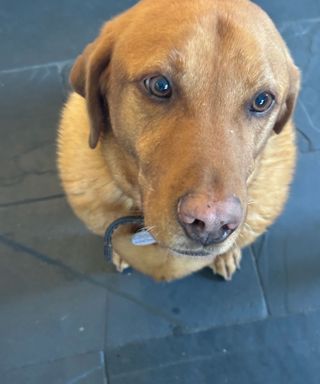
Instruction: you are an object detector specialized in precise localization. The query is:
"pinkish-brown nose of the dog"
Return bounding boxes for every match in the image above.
[178,194,242,245]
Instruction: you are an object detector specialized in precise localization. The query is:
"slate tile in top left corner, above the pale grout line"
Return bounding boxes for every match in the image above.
[0,0,136,70]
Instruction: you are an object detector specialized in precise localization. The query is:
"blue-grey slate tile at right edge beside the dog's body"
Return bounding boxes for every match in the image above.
[254,152,320,315]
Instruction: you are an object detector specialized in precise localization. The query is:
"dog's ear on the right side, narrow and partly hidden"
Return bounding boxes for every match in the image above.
[273,63,300,134]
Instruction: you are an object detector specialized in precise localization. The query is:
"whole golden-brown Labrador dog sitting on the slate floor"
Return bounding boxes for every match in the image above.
[58,0,300,281]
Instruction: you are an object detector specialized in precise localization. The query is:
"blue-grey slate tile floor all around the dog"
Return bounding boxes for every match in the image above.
[0,0,320,384]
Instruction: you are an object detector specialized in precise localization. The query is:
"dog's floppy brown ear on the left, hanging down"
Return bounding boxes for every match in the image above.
[70,24,113,148]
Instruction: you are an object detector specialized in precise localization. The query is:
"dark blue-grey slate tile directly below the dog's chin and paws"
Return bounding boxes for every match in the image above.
[106,248,267,349]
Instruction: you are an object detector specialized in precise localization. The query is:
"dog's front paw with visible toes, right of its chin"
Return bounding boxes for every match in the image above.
[210,247,241,281]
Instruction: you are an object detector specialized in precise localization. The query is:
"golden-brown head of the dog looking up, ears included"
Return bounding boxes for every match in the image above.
[71,0,299,256]
